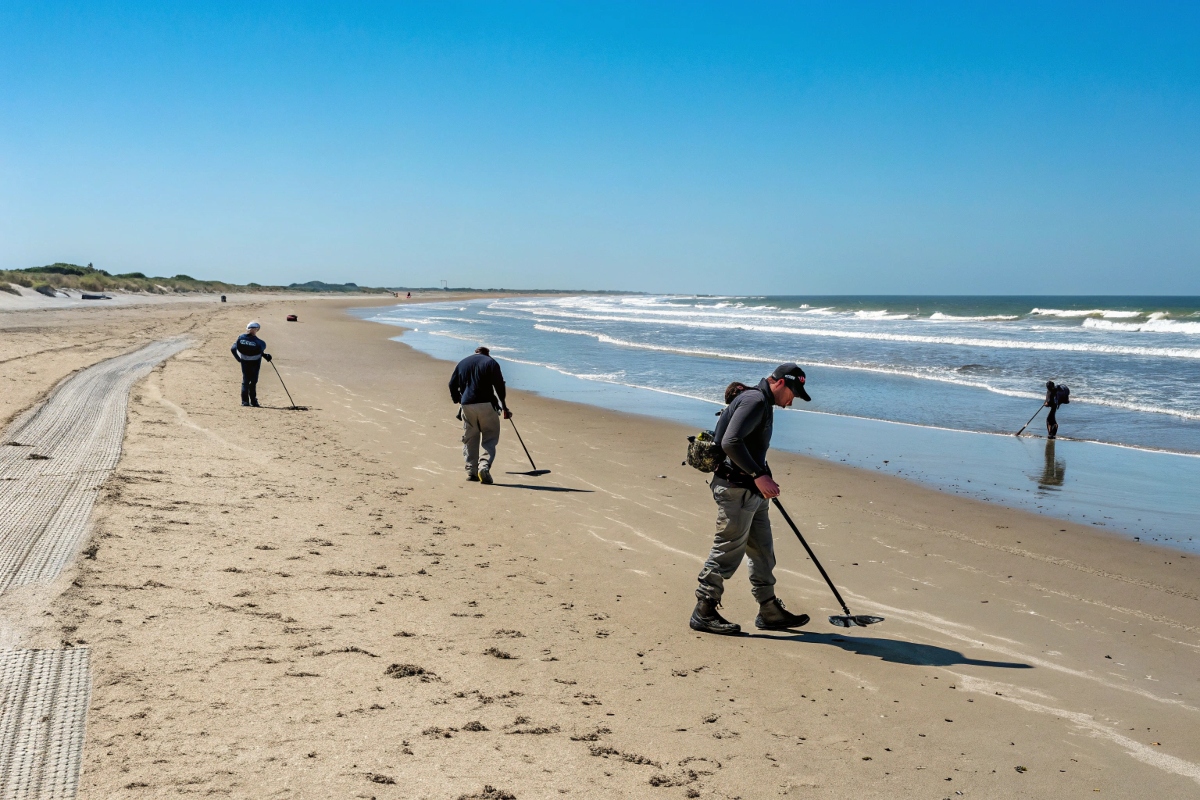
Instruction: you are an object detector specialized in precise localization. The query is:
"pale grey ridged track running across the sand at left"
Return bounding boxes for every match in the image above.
[0,338,187,800]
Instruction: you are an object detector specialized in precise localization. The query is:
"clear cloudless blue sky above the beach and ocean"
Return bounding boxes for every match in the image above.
[0,0,1200,294]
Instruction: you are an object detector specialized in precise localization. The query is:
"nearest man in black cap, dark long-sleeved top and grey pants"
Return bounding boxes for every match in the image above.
[689,363,812,634]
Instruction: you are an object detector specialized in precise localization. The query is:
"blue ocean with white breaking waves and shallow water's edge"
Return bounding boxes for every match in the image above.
[362,295,1200,548]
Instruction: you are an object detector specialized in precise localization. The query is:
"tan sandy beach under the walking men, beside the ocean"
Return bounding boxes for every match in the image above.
[0,300,1200,800]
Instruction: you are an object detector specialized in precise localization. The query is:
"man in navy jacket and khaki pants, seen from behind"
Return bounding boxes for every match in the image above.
[450,347,512,483]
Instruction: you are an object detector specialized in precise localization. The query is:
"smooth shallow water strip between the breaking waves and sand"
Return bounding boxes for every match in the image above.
[367,312,1200,553]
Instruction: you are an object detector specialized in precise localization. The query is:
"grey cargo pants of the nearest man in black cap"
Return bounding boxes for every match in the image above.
[696,481,775,603]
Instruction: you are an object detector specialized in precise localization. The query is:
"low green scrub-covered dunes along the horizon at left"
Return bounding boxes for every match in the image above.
[0,261,389,296]
